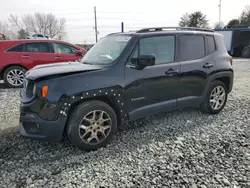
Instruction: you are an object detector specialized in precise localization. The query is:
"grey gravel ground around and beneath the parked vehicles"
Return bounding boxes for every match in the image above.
[0,61,250,188]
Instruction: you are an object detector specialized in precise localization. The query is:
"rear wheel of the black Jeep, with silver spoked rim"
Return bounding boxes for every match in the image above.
[200,80,228,114]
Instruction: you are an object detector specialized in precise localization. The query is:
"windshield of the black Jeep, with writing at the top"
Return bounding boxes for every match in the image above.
[81,35,131,64]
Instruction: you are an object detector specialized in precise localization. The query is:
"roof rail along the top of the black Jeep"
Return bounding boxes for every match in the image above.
[136,27,214,33]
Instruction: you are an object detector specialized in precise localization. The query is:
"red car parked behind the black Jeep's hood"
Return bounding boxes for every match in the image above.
[0,39,87,88]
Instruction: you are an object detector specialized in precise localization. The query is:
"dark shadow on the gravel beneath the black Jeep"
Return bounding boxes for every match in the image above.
[0,106,218,171]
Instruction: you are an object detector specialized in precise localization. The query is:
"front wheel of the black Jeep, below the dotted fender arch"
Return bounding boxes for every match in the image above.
[67,101,117,151]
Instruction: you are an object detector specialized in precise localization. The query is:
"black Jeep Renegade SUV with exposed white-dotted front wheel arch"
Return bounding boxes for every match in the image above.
[20,27,233,150]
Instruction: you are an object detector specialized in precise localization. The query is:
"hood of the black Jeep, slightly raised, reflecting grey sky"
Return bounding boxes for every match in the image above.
[25,62,103,80]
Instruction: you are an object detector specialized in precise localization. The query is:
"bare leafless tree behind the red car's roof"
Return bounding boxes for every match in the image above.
[9,13,66,39]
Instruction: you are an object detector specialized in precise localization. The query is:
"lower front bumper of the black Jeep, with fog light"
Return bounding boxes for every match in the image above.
[19,113,66,141]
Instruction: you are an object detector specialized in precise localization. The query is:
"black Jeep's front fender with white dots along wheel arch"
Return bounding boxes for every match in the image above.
[36,65,127,122]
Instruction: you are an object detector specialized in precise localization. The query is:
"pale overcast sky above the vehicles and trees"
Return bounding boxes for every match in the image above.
[0,0,250,43]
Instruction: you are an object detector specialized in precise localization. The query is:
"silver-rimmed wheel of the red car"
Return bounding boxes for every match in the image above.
[3,66,26,88]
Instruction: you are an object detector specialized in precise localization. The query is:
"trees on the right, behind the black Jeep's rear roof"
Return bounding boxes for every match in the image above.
[179,6,250,29]
